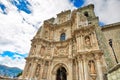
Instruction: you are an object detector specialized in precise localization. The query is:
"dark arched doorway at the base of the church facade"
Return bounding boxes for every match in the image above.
[56,67,67,80]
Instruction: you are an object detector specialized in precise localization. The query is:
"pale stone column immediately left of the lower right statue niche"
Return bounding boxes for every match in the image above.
[82,55,89,80]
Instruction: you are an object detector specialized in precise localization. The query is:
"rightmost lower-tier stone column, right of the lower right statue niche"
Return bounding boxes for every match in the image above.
[95,53,104,80]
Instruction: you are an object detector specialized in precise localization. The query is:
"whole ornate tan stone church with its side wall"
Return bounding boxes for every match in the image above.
[22,4,120,80]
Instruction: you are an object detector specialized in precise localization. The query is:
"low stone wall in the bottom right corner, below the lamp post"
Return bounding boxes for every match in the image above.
[107,63,120,80]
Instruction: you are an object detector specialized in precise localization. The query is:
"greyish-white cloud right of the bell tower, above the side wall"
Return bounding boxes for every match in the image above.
[85,0,120,24]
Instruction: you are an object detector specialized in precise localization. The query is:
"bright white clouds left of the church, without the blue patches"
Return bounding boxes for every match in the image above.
[0,0,74,68]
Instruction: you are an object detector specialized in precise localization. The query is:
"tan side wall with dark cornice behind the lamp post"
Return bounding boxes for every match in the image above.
[102,22,120,64]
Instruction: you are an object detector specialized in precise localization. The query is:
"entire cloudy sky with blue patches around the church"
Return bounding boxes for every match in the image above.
[0,0,120,69]
